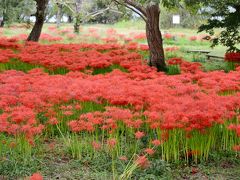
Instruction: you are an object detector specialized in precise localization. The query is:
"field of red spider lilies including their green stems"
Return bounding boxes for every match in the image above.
[0,26,240,179]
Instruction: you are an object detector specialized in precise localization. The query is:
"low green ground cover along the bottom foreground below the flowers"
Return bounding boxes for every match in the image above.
[0,138,240,180]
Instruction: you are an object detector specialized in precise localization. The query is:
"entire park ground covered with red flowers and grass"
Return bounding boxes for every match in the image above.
[0,22,240,180]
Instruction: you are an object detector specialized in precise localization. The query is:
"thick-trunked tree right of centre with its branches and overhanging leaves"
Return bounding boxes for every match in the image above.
[113,0,216,71]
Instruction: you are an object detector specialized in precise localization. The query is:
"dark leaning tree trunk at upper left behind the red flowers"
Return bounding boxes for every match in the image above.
[27,0,48,42]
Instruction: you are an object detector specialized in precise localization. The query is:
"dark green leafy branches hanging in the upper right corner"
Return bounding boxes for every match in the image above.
[195,0,240,52]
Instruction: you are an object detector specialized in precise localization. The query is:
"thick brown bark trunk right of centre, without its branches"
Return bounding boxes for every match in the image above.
[146,4,167,71]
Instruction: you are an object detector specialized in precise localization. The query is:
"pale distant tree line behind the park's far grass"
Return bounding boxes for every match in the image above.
[0,0,206,29]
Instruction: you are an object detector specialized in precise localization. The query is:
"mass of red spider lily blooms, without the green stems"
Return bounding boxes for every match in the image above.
[0,35,240,161]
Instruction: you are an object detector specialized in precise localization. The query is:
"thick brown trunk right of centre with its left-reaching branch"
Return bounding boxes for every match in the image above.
[113,0,171,71]
